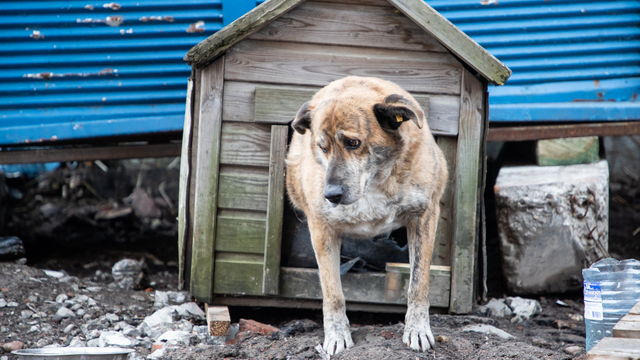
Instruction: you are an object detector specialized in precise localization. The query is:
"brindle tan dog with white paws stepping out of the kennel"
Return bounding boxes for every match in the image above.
[286,76,448,355]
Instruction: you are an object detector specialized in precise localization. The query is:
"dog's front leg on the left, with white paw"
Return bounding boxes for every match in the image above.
[309,220,353,355]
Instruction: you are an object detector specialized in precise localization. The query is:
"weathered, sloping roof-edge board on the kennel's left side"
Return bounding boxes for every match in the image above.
[184,0,304,68]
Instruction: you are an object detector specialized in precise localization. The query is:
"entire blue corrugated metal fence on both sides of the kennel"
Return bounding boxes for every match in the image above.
[0,0,640,144]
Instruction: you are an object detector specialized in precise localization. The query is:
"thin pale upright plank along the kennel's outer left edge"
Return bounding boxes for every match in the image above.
[178,78,193,288]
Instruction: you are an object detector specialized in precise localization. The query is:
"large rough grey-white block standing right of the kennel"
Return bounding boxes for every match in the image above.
[494,161,609,295]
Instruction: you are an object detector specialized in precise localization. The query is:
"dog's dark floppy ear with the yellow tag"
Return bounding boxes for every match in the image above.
[373,94,425,130]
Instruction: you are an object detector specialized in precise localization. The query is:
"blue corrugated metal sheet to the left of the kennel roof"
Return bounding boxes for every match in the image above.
[0,0,229,144]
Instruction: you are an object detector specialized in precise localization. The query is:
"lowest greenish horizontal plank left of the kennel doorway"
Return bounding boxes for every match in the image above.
[213,253,264,295]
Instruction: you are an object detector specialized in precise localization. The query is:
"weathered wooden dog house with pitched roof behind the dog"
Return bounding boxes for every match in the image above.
[179,0,511,313]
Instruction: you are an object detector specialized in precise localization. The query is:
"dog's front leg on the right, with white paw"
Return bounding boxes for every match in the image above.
[402,208,440,351]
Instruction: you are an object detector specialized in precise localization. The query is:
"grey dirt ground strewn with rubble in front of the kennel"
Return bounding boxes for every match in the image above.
[0,253,585,360]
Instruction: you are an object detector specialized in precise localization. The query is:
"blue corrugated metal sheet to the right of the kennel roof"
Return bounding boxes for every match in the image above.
[426,0,640,122]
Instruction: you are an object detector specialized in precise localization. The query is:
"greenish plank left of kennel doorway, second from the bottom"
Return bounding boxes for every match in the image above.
[216,210,267,254]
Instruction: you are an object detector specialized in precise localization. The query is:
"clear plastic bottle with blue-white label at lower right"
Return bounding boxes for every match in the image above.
[582,258,640,351]
